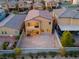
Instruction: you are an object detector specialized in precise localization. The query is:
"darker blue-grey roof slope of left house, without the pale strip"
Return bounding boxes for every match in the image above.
[4,15,26,30]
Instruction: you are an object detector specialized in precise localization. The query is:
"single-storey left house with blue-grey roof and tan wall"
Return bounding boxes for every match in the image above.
[0,15,26,37]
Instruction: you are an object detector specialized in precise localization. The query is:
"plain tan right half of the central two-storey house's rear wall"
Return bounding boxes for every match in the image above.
[36,16,52,33]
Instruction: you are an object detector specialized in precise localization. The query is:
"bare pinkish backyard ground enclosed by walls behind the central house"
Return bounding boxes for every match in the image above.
[17,34,60,48]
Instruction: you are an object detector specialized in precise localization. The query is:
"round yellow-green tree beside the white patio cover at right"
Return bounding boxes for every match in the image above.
[61,31,74,47]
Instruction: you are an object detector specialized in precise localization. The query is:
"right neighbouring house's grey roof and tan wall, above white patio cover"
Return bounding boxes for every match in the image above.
[58,9,79,25]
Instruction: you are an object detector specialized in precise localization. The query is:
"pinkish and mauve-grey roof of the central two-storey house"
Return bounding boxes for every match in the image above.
[25,10,52,21]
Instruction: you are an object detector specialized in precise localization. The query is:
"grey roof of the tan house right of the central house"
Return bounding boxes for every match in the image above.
[59,9,79,19]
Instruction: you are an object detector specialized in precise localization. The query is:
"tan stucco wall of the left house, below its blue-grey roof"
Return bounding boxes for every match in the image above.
[0,27,19,36]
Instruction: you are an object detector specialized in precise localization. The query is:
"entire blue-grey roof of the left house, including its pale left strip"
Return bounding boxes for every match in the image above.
[0,14,26,30]
